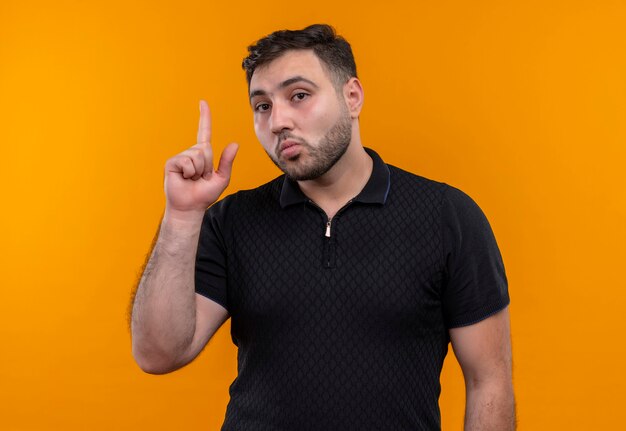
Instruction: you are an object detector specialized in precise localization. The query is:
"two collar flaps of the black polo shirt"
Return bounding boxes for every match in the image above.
[280,148,391,208]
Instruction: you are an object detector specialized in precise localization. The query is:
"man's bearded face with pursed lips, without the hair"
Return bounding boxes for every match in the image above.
[250,50,352,181]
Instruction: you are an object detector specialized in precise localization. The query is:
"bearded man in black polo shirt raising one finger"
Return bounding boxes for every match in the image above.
[132,25,515,431]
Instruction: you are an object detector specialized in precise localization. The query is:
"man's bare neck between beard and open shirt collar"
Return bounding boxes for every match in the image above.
[298,139,373,218]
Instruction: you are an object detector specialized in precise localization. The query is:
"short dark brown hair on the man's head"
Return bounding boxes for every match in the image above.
[242,24,357,86]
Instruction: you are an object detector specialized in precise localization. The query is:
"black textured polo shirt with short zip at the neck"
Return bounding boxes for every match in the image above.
[196,150,509,431]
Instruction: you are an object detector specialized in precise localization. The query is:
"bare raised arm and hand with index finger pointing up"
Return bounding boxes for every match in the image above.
[131,101,238,374]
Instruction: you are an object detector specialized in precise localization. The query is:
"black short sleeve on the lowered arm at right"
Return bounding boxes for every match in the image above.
[442,185,510,328]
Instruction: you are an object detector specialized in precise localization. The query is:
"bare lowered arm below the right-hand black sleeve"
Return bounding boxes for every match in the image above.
[450,307,516,431]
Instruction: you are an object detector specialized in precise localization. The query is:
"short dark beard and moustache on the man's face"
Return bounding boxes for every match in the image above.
[267,110,352,181]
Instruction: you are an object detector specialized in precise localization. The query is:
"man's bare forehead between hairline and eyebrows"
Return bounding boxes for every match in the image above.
[250,50,330,93]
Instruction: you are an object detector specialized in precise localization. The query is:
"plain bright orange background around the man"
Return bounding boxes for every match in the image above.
[0,0,626,430]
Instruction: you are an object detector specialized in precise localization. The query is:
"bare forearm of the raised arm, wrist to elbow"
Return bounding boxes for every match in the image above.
[131,212,202,373]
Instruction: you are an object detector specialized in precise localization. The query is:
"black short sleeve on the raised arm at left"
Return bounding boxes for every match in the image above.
[195,198,230,310]
